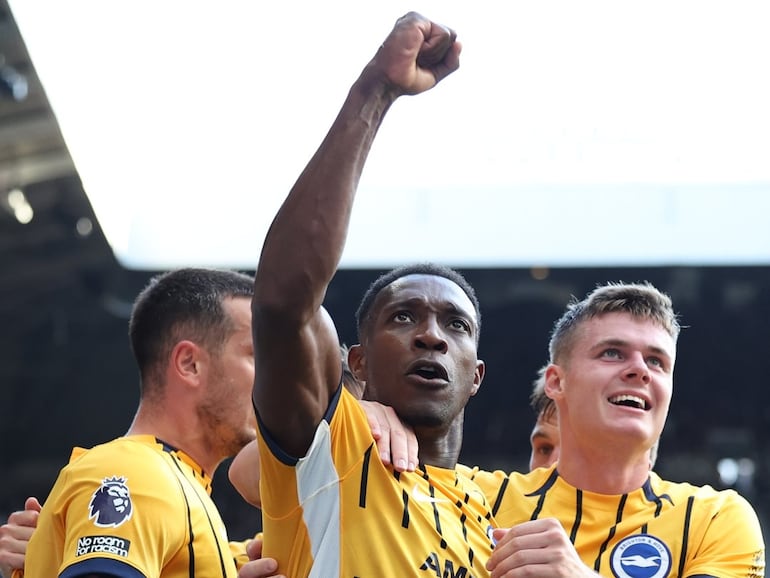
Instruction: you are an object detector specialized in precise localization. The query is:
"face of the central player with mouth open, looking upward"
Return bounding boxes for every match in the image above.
[353,274,484,429]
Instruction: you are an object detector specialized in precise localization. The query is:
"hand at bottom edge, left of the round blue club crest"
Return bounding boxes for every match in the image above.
[487,518,599,578]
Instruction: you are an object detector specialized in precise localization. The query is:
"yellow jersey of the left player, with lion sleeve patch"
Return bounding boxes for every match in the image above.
[24,435,237,578]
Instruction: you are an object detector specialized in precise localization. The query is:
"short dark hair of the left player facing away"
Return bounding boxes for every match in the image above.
[128,268,254,393]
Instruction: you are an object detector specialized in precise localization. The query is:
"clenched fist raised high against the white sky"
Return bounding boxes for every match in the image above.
[370,12,462,94]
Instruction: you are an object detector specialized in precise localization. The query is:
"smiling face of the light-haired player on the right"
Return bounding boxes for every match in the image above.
[546,313,675,454]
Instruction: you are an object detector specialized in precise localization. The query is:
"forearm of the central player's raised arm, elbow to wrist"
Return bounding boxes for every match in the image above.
[255,65,396,323]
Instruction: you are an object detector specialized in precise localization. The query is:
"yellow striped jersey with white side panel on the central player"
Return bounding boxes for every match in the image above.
[258,388,494,578]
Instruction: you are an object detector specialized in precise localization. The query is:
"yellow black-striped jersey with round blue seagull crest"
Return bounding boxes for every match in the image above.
[456,466,765,578]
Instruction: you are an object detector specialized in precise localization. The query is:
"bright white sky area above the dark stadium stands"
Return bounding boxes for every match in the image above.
[11,0,770,269]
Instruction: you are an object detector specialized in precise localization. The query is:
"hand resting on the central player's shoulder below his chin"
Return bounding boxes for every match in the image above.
[360,401,418,472]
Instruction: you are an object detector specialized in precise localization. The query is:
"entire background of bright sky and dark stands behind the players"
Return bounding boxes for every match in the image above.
[0,0,770,538]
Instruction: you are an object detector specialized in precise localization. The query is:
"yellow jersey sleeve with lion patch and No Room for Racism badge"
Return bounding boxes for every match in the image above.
[49,444,188,576]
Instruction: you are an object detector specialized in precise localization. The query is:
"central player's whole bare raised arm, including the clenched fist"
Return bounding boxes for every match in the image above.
[253,13,460,456]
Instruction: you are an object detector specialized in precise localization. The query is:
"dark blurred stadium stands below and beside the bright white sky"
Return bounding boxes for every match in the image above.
[0,0,770,538]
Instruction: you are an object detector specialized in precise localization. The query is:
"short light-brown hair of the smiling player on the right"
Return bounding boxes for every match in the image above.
[548,282,681,363]
